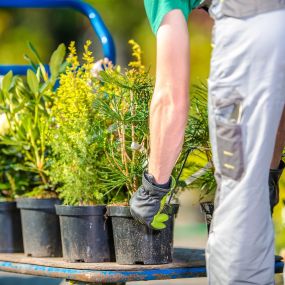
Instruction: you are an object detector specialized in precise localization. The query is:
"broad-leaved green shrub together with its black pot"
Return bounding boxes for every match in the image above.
[0,42,65,257]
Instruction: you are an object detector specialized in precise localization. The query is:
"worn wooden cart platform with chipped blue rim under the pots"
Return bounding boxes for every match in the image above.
[0,248,284,284]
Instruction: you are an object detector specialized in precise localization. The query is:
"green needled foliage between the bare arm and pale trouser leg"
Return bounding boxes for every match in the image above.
[179,84,217,201]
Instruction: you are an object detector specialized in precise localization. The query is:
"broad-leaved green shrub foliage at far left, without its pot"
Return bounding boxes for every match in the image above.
[0,44,65,198]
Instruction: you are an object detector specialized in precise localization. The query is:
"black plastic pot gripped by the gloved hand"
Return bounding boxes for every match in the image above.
[108,205,179,264]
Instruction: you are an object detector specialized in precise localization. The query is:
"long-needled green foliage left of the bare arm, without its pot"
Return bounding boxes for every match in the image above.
[94,40,153,204]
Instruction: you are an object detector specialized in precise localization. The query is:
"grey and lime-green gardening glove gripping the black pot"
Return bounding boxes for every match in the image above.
[130,172,172,230]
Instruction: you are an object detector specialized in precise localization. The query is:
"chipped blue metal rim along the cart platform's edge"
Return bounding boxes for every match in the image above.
[0,256,284,285]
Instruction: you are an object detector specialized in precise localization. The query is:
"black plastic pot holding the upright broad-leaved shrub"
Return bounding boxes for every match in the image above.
[17,198,62,257]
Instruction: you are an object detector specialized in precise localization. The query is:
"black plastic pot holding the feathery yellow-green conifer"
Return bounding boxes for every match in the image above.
[56,205,115,262]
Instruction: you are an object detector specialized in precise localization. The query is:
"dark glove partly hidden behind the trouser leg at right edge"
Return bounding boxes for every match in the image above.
[269,160,285,214]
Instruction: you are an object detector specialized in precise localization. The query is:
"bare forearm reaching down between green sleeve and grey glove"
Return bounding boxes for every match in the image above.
[145,10,190,184]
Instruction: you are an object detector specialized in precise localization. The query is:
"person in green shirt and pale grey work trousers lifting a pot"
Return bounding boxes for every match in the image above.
[130,0,285,285]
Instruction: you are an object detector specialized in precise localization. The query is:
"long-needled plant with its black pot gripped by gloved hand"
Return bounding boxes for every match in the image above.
[91,41,178,264]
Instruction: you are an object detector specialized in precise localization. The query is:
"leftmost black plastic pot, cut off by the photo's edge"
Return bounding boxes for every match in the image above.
[0,202,24,253]
